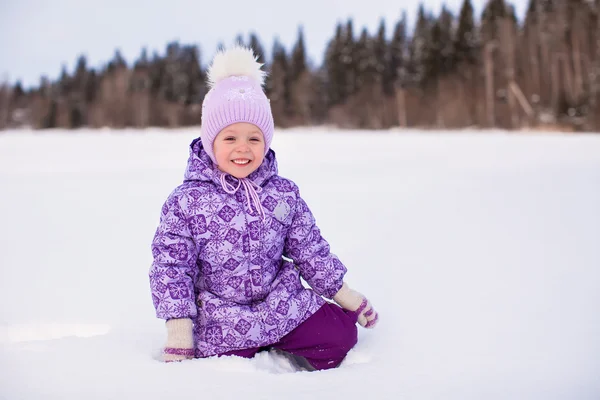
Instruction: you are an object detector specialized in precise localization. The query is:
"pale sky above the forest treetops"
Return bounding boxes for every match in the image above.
[0,0,525,86]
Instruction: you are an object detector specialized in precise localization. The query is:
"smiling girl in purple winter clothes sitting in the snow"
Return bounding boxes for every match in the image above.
[149,47,377,370]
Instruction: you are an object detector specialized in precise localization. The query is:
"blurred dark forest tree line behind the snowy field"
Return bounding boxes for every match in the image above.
[0,0,600,132]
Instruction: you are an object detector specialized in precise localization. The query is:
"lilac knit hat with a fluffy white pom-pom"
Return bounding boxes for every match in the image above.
[200,46,275,164]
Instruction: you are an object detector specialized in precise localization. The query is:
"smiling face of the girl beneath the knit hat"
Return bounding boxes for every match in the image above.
[213,122,265,179]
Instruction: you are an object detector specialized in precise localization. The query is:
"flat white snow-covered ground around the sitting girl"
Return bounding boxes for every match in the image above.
[0,129,600,400]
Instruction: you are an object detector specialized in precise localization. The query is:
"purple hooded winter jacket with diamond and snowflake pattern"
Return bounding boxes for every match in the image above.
[149,139,346,357]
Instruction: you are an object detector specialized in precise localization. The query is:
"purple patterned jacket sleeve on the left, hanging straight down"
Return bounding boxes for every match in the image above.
[149,189,198,320]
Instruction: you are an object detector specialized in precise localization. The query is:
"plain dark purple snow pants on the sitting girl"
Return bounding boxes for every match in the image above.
[220,303,358,370]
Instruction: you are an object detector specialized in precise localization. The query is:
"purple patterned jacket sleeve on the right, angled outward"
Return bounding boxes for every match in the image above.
[284,186,346,299]
